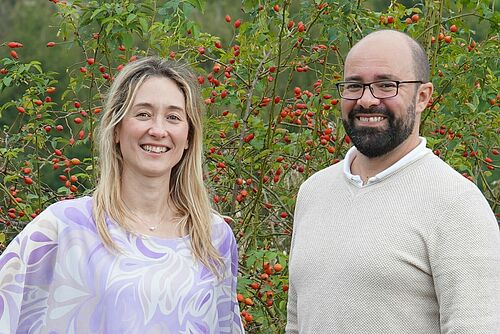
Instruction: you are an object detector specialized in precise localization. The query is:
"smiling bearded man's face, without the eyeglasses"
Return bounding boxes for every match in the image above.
[341,36,419,158]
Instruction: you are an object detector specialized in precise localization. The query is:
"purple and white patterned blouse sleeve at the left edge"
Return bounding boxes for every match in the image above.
[0,210,57,334]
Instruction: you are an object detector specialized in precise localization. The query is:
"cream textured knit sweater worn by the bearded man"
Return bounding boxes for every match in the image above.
[286,153,500,334]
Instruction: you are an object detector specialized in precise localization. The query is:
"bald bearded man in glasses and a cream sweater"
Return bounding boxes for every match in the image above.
[286,30,500,334]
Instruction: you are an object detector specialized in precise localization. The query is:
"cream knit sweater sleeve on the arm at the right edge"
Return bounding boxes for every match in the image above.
[429,189,500,334]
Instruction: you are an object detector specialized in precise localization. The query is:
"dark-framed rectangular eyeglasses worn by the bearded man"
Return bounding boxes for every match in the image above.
[335,80,423,100]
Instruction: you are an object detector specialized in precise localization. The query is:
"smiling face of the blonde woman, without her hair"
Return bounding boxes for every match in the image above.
[116,77,189,178]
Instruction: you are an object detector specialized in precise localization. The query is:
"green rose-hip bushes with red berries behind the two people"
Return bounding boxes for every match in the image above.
[0,0,500,333]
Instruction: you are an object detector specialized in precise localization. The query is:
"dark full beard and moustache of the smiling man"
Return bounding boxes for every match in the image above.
[342,102,416,158]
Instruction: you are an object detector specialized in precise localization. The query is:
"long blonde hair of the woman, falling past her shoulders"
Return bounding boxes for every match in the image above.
[93,57,223,278]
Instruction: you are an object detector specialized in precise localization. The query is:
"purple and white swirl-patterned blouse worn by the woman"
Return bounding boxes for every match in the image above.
[0,197,243,334]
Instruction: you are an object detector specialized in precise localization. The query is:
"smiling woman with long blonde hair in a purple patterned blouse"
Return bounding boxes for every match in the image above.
[0,57,243,333]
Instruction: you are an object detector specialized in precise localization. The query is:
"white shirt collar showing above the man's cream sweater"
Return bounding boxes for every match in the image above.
[344,137,430,188]
